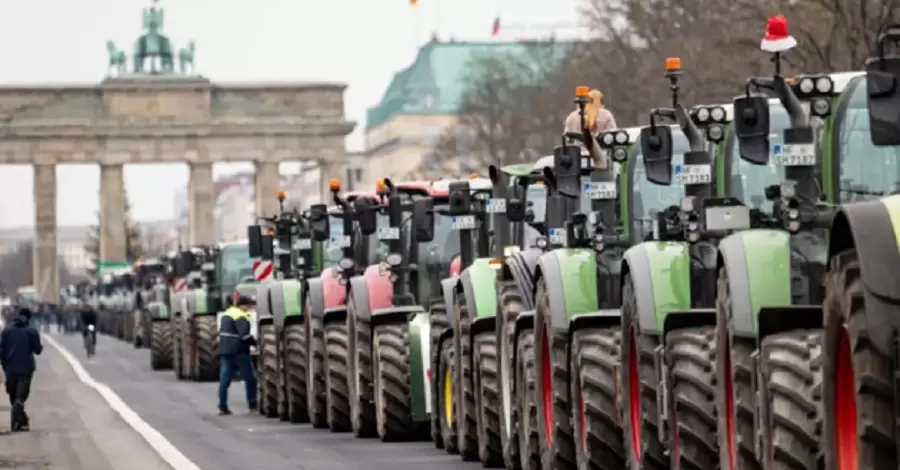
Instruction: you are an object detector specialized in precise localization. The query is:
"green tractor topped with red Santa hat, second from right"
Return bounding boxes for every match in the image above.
[713,46,868,468]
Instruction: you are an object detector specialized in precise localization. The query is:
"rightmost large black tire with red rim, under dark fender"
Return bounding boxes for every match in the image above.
[822,247,898,470]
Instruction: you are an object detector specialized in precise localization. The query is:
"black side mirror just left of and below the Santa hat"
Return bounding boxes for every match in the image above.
[734,96,769,165]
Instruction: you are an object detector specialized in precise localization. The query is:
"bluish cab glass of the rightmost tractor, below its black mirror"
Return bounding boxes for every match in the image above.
[835,79,900,202]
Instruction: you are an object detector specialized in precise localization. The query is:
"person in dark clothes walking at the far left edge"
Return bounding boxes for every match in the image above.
[0,308,44,431]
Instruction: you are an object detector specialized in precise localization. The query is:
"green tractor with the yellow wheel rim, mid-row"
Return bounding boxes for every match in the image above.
[429,177,496,458]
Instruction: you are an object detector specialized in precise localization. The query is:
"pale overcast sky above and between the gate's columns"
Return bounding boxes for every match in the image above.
[0,0,584,228]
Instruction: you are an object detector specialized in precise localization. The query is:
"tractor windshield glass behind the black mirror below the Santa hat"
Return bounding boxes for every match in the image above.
[725,101,791,212]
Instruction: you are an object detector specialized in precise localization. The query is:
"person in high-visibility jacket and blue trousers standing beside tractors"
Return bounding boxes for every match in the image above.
[219,294,257,415]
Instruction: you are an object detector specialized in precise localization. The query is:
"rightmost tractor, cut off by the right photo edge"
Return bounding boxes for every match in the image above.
[822,26,900,469]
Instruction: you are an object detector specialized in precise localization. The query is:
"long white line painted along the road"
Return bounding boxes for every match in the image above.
[41,334,200,470]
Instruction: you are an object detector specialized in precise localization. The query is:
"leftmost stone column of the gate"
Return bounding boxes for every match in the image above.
[32,164,59,303]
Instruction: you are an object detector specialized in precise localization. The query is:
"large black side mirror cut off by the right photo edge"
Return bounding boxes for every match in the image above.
[866,25,900,146]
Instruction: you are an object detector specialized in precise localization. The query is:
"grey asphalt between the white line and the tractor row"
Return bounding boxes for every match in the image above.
[49,335,481,470]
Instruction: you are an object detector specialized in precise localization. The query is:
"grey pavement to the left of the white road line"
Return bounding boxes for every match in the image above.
[0,334,171,470]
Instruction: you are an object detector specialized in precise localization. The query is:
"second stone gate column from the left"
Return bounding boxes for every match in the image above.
[100,164,128,265]
